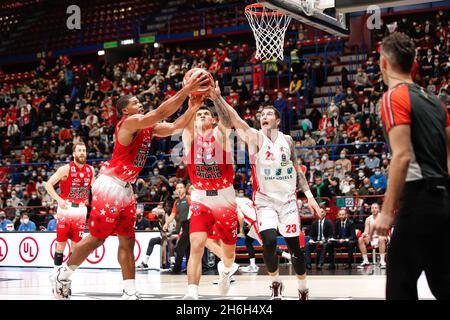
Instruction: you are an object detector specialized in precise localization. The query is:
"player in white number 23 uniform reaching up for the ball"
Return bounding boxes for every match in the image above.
[209,84,320,300]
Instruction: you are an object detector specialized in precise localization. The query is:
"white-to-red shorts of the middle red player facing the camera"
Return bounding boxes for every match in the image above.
[189,187,238,245]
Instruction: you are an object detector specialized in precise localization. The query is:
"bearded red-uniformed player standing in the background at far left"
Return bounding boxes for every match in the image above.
[45,142,95,272]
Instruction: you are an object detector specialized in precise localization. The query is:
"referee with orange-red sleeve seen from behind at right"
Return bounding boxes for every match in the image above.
[374,33,450,300]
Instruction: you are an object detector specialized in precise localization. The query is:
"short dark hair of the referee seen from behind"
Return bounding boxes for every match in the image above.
[381,32,416,73]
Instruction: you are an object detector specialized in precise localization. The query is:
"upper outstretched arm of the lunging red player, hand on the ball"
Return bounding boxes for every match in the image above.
[121,75,210,132]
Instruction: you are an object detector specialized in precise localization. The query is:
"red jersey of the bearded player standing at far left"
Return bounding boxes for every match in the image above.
[59,161,94,204]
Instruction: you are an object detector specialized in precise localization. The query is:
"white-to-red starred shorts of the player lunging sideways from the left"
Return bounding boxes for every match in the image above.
[89,174,136,239]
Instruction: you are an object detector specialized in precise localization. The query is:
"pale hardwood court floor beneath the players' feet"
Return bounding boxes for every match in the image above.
[0,264,434,300]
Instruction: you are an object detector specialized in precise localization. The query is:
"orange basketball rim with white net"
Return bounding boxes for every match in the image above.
[245,3,291,60]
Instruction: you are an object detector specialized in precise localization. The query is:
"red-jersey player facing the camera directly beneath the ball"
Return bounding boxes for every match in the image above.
[183,95,238,299]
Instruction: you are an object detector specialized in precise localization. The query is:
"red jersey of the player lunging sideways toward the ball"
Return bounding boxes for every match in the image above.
[100,120,153,183]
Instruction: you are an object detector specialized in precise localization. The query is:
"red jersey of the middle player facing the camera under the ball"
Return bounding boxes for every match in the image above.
[187,134,234,190]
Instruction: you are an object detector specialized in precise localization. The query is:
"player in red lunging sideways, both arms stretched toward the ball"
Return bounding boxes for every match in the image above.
[50,75,210,300]
